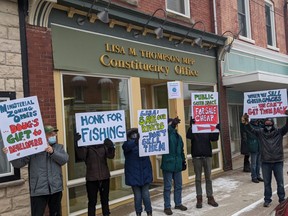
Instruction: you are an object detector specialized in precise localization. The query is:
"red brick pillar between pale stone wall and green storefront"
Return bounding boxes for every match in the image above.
[26,25,56,126]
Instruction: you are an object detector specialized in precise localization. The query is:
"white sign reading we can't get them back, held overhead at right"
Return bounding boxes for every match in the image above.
[243,89,287,119]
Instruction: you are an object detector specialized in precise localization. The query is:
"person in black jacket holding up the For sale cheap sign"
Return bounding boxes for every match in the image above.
[186,116,220,208]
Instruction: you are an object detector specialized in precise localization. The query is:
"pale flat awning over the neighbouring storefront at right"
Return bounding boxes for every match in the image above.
[222,71,288,92]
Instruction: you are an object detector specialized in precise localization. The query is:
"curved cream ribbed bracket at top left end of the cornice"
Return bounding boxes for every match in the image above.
[28,0,57,27]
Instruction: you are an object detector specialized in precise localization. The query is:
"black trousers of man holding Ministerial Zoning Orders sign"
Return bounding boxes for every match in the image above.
[31,191,62,216]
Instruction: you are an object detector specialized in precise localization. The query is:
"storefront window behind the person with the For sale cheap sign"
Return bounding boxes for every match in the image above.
[183,83,221,178]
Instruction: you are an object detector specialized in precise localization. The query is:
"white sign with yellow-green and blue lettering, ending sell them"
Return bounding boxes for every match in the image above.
[138,109,169,157]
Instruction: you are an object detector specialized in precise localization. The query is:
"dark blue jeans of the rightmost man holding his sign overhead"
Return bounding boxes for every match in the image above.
[262,162,285,203]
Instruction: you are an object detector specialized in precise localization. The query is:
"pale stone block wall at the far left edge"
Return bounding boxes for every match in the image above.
[0,0,30,216]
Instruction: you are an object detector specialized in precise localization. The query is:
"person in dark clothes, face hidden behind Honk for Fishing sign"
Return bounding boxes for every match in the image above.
[74,133,115,216]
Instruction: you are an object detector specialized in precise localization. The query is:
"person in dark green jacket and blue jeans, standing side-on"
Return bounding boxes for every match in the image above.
[161,117,187,215]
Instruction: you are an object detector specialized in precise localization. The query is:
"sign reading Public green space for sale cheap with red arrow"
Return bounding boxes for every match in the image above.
[191,92,219,133]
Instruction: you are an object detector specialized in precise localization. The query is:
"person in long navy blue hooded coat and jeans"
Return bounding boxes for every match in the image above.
[122,128,153,216]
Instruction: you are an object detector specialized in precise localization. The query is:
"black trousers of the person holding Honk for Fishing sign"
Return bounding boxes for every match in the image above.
[86,179,110,216]
